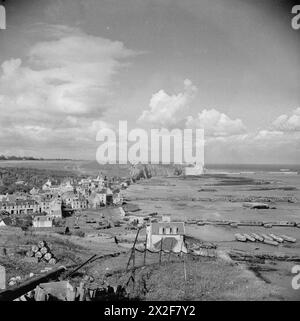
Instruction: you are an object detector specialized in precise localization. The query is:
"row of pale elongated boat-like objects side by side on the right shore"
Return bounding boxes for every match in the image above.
[234,233,297,246]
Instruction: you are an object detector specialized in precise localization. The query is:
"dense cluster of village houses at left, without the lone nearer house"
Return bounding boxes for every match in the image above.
[0,175,130,227]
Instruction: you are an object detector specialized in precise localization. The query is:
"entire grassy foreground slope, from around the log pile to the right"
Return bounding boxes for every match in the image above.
[0,228,284,300]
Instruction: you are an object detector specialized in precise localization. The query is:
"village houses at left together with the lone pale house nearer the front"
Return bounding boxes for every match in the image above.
[0,170,186,252]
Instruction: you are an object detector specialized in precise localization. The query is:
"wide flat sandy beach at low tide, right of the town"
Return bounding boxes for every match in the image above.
[122,172,300,300]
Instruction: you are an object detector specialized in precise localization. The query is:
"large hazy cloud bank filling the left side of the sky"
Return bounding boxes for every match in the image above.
[0,26,135,156]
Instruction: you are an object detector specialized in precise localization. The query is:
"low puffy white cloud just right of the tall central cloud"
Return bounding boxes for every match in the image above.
[186,109,246,137]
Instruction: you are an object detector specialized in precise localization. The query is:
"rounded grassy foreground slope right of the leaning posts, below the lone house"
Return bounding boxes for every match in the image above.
[102,254,284,301]
